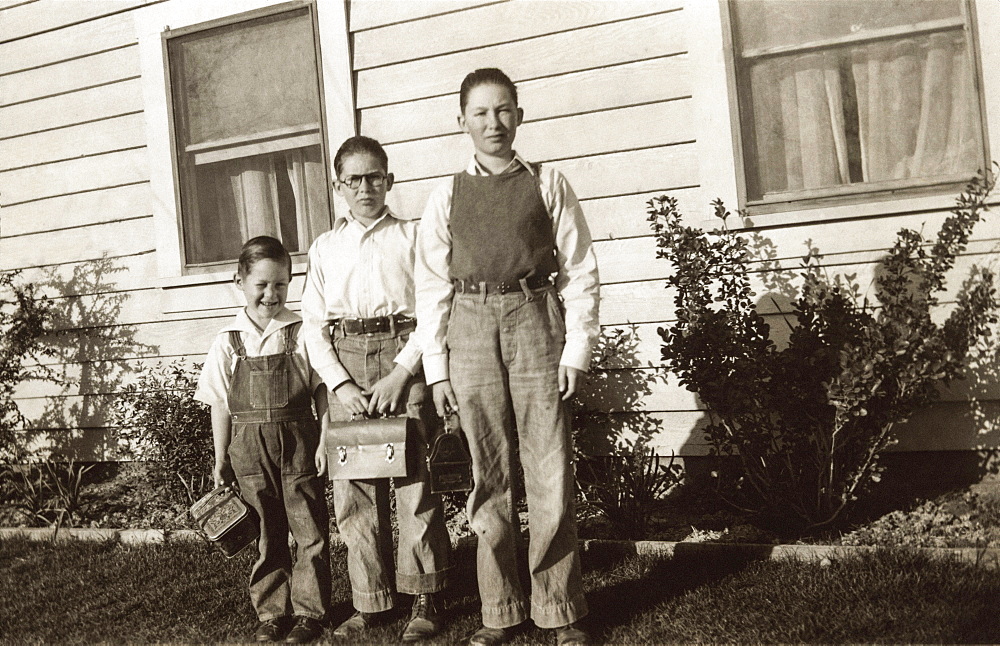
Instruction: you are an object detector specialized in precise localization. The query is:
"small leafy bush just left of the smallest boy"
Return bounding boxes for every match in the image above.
[112,361,215,502]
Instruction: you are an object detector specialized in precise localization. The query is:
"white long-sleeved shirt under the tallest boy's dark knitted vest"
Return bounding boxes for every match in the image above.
[415,153,600,384]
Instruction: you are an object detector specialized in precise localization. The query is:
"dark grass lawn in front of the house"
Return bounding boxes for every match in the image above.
[0,540,1000,644]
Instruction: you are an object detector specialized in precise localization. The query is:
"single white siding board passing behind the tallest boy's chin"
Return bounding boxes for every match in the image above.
[386,100,691,181]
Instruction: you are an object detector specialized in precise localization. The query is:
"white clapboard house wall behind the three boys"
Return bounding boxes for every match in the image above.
[0,0,1000,466]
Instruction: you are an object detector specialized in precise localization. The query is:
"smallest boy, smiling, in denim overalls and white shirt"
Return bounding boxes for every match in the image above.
[195,236,330,643]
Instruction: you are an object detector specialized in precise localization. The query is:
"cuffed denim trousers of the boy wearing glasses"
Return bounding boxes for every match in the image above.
[330,332,451,612]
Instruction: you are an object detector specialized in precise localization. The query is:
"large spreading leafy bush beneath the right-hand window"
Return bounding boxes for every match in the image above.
[649,174,996,528]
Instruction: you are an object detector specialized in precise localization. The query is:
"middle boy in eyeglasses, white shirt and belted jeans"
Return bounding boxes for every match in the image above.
[302,136,450,642]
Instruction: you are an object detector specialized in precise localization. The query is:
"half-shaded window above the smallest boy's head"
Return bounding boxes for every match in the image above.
[164,5,331,267]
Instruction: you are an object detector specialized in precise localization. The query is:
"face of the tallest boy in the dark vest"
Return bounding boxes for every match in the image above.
[458,83,524,158]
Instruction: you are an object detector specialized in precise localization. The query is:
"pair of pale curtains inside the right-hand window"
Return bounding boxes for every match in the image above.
[751,33,978,193]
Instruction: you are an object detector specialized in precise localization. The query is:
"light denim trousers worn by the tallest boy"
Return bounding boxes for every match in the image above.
[448,286,587,628]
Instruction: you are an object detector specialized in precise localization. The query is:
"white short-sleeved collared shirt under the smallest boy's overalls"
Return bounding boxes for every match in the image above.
[194,307,323,410]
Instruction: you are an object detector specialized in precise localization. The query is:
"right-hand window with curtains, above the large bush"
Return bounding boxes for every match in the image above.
[729,0,985,205]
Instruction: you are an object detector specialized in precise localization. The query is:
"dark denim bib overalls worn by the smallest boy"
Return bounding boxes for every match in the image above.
[229,323,330,621]
